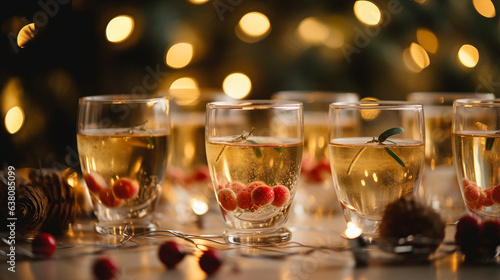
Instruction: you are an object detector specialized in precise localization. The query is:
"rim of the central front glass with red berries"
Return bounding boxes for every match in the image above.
[207,99,303,110]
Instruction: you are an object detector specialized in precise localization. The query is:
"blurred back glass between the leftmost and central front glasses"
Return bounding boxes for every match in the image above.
[167,89,234,223]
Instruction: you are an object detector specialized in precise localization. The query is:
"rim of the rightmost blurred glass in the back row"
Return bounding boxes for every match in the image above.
[407,91,495,105]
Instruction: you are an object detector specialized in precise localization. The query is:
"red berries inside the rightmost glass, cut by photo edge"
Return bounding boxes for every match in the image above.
[462,178,500,210]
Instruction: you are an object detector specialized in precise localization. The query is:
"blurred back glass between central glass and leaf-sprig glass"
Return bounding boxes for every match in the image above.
[271,91,359,216]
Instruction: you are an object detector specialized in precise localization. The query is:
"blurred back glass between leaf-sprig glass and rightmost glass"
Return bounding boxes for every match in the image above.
[407,92,494,223]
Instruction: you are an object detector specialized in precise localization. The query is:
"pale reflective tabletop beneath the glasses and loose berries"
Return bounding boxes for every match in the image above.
[0,203,500,280]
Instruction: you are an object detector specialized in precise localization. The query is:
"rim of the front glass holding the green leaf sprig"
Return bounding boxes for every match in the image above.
[329,100,423,110]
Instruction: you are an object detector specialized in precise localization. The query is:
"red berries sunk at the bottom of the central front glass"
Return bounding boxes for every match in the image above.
[217,181,290,212]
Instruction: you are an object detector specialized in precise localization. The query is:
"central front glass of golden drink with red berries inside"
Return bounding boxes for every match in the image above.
[205,100,304,245]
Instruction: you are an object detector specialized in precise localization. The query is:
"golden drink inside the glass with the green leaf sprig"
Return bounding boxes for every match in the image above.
[329,137,424,221]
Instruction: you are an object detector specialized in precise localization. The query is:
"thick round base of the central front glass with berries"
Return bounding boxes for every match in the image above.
[223,228,292,245]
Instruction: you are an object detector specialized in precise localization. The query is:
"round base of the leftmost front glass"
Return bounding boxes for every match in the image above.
[94,220,158,235]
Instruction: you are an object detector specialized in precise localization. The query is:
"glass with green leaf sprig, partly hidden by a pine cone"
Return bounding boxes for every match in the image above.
[329,101,424,238]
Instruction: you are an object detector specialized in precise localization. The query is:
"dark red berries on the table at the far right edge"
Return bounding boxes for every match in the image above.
[455,215,500,260]
